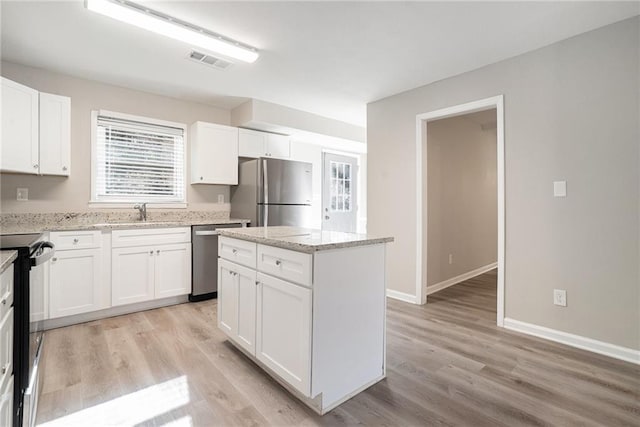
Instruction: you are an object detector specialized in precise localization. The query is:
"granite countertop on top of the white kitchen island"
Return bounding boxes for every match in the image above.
[218,227,393,253]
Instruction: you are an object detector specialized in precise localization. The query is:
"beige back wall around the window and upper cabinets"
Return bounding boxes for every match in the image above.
[0,62,230,212]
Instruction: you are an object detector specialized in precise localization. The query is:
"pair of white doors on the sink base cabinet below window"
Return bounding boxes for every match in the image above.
[111,243,191,306]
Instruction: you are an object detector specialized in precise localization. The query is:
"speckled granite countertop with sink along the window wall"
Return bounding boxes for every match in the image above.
[0,212,250,235]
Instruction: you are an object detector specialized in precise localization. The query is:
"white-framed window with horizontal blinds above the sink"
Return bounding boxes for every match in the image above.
[91,111,186,204]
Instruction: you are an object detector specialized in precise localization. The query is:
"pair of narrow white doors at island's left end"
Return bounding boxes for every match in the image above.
[218,259,257,356]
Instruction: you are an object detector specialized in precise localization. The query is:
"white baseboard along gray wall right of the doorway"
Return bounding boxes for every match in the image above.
[504,318,640,365]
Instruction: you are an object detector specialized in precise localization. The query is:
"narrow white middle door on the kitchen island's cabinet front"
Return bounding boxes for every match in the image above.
[233,265,257,356]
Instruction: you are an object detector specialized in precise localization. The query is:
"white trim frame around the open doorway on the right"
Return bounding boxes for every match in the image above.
[415,95,506,326]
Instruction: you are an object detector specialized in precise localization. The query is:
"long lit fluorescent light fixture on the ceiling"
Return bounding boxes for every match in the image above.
[86,0,258,62]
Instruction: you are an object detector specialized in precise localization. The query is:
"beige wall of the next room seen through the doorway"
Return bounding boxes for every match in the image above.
[423,109,498,286]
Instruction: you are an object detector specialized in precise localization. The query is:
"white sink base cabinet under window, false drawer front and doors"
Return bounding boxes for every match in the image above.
[111,227,191,306]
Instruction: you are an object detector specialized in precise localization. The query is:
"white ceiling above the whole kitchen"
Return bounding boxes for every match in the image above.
[1,0,640,126]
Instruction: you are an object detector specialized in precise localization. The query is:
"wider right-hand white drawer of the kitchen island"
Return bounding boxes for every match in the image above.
[257,245,313,286]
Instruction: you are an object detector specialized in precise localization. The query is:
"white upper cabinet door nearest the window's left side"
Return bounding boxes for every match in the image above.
[40,93,71,176]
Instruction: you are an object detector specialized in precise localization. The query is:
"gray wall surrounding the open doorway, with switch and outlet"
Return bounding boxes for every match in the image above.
[367,17,640,349]
